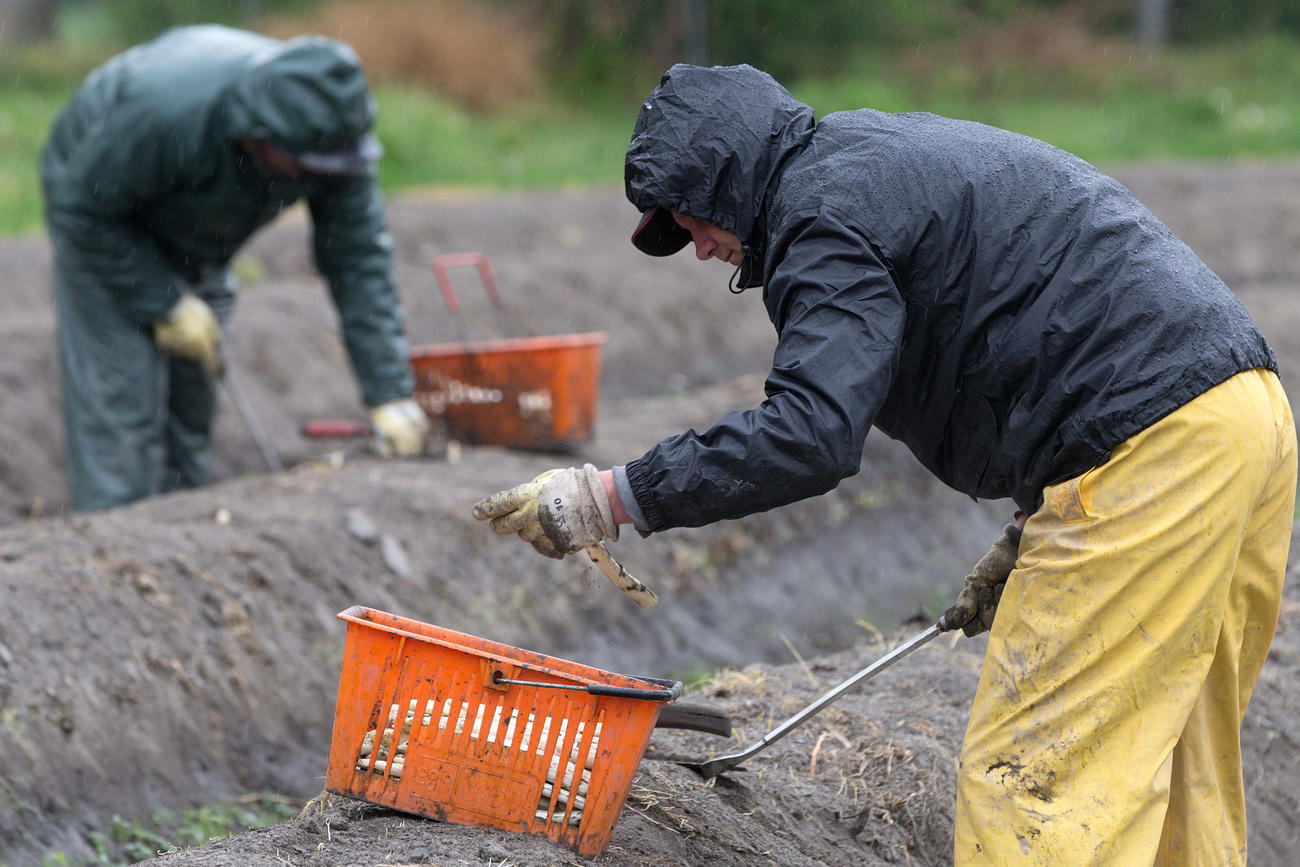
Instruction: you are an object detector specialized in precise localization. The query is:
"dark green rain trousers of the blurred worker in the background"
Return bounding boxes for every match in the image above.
[55,261,235,511]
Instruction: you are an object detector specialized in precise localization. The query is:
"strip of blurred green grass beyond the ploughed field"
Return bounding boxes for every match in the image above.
[0,36,1300,234]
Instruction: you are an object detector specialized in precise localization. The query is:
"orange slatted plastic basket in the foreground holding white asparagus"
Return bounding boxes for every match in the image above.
[325,606,681,855]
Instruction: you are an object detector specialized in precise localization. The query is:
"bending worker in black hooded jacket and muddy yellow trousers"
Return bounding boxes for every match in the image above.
[475,65,1296,864]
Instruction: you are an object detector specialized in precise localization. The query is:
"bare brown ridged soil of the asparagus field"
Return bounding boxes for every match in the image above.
[0,164,1300,867]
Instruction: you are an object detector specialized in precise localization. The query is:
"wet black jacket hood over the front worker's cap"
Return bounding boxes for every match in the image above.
[624,64,815,286]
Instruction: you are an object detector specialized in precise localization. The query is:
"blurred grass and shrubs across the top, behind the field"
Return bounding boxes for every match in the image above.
[0,0,1300,233]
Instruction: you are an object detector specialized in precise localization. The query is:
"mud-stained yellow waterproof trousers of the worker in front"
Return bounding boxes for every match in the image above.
[954,370,1296,867]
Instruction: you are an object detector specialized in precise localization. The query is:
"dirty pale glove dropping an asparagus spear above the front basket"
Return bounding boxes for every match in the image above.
[475,464,619,560]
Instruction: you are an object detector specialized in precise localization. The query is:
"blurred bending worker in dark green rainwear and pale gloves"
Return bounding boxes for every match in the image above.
[40,26,429,511]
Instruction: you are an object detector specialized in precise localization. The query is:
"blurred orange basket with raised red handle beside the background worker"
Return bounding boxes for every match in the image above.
[410,252,607,451]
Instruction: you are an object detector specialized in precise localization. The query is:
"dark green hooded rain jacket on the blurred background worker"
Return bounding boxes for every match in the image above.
[42,25,412,406]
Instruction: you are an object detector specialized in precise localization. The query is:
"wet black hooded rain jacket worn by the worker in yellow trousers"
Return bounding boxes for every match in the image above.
[625,65,1277,530]
